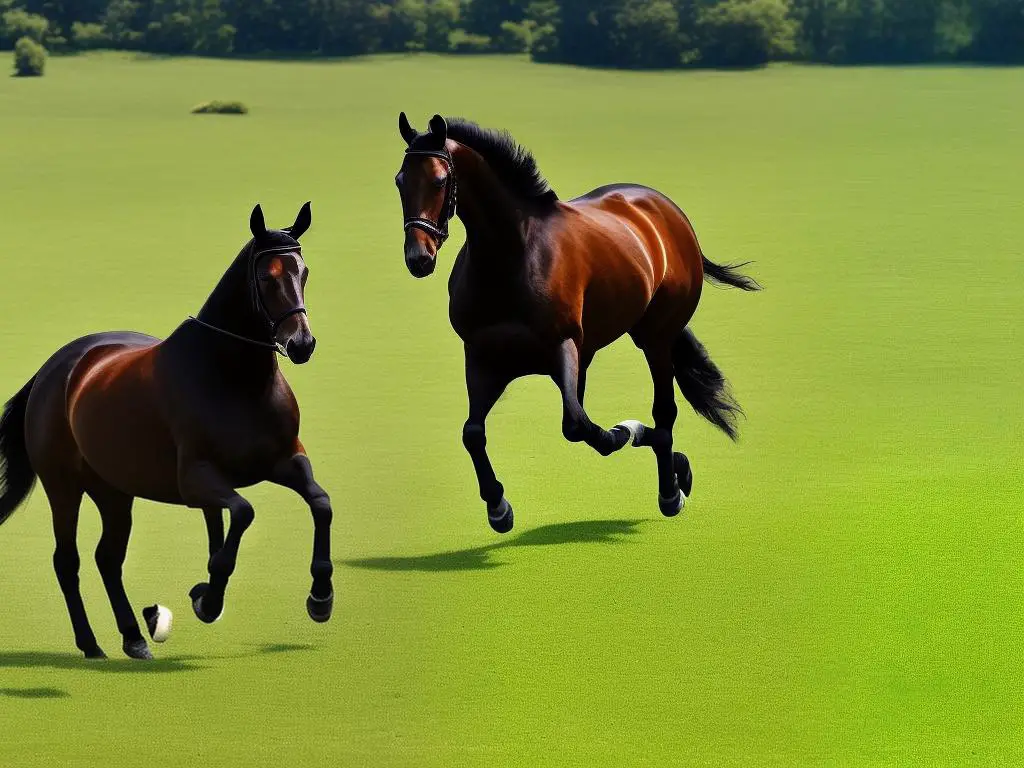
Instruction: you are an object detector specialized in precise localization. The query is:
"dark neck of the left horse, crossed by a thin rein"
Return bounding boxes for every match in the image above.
[196,243,278,379]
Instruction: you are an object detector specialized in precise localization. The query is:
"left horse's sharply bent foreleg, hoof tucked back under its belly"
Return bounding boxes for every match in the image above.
[178,461,256,624]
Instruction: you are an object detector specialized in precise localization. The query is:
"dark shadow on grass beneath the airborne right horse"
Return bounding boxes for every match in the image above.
[345,520,646,572]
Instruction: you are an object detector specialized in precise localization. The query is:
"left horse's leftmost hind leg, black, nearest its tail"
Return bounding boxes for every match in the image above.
[41,478,106,658]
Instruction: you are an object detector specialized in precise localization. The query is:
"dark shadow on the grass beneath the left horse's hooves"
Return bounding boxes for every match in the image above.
[0,643,316,671]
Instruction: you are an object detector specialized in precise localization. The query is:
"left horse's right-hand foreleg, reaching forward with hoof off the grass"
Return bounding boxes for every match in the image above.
[270,454,334,622]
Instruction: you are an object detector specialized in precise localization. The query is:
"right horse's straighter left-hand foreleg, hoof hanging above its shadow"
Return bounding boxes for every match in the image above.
[462,350,514,534]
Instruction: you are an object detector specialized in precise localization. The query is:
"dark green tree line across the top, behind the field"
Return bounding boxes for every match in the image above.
[0,0,1024,69]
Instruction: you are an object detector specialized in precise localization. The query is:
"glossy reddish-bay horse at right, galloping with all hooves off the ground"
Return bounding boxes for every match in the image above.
[395,113,760,534]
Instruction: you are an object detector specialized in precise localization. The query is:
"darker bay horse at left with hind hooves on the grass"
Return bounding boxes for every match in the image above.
[0,203,334,658]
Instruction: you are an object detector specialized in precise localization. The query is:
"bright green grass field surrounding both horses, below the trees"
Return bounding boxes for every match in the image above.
[0,55,1024,768]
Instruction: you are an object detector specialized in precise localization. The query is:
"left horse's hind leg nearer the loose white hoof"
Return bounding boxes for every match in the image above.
[88,485,153,659]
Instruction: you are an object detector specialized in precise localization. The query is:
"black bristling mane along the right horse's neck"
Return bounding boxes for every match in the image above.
[445,118,558,206]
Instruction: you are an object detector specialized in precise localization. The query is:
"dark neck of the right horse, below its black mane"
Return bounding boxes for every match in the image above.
[450,141,527,271]
